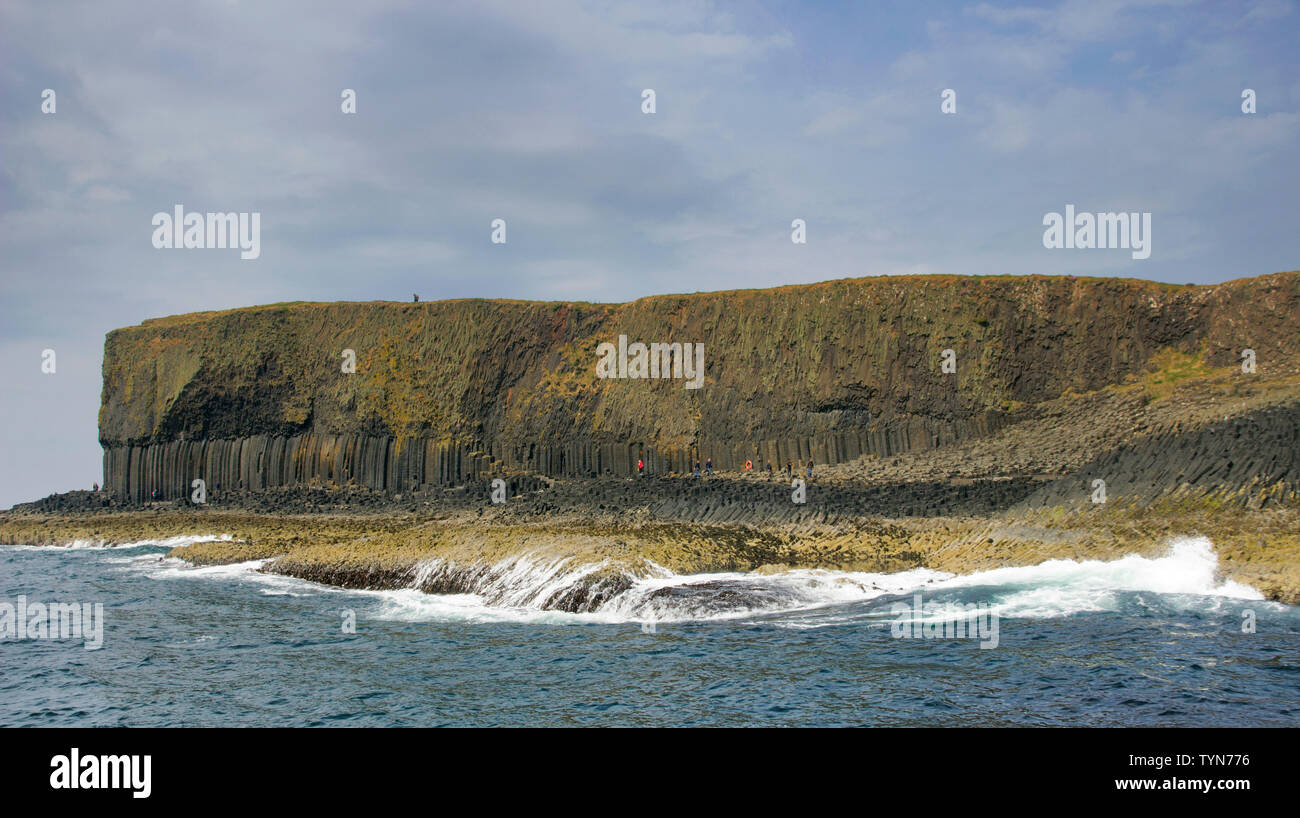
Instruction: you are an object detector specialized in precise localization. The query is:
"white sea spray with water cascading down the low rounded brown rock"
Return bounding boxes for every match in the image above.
[371,538,1262,624]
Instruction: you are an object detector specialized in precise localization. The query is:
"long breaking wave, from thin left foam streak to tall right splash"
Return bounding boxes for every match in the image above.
[114,537,1290,628]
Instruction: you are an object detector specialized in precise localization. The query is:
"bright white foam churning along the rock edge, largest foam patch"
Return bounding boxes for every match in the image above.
[364,537,1264,627]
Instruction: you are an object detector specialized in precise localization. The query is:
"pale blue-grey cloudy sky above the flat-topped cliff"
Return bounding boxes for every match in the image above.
[0,0,1300,507]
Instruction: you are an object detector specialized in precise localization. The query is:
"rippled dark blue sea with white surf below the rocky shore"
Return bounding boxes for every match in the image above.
[0,540,1300,726]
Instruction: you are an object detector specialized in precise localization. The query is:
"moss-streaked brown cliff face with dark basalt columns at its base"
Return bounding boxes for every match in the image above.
[100,273,1300,501]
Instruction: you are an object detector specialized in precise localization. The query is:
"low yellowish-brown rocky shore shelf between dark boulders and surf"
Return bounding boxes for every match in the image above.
[0,477,1300,603]
